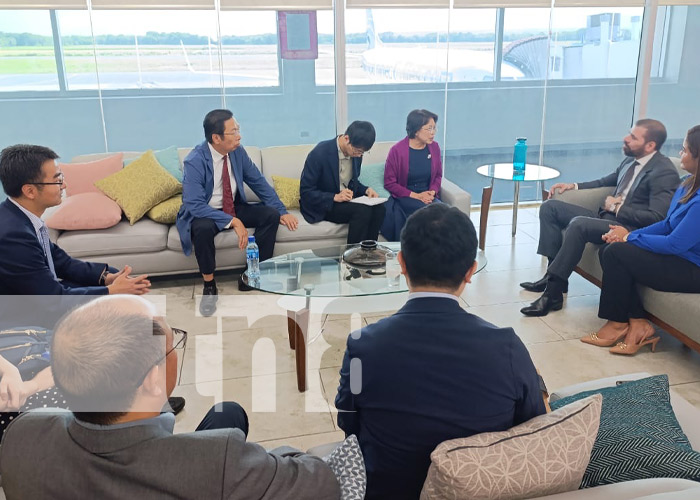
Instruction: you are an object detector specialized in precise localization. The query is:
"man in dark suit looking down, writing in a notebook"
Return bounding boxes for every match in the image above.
[299,121,386,244]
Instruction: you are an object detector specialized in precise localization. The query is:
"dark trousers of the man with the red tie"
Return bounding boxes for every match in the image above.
[191,203,280,274]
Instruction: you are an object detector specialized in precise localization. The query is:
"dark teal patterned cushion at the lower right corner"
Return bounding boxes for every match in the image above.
[552,375,700,488]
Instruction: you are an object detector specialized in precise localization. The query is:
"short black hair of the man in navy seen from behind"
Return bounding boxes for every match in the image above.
[401,203,478,290]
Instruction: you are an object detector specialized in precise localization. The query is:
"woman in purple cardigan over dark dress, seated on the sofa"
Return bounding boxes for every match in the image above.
[382,109,442,241]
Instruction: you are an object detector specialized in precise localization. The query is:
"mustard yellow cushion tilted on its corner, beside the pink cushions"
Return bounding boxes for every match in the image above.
[95,150,182,225]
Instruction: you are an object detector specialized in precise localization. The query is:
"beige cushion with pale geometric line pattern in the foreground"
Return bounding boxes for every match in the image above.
[421,396,602,500]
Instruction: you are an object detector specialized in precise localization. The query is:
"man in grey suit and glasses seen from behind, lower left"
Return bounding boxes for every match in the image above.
[0,296,340,500]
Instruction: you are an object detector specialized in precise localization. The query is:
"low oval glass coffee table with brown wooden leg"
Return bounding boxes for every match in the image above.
[243,242,487,392]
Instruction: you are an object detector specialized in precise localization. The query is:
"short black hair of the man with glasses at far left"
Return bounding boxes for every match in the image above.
[0,144,58,198]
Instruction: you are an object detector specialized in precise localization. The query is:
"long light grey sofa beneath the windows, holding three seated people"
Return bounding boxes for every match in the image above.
[51,142,471,276]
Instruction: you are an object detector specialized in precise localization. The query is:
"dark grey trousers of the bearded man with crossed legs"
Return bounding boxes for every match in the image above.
[537,200,619,281]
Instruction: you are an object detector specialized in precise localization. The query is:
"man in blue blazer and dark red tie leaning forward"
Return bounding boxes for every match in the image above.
[176,109,299,316]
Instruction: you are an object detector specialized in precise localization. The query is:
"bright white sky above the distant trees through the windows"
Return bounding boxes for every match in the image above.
[0,7,643,39]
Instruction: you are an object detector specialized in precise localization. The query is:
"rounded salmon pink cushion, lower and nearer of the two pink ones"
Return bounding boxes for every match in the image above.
[46,193,122,231]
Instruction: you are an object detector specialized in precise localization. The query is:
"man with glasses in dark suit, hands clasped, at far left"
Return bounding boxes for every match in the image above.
[0,144,151,295]
